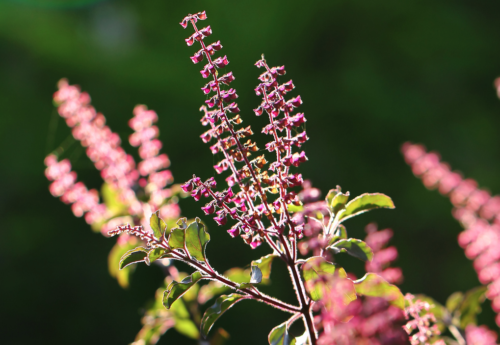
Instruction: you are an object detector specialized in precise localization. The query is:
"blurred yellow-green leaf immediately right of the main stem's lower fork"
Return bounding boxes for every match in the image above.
[302,256,348,301]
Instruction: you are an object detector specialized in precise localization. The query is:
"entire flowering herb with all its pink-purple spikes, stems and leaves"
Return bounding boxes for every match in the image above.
[45,12,500,345]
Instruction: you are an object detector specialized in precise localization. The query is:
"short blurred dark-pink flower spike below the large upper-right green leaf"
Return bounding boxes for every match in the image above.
[365,223,403,284]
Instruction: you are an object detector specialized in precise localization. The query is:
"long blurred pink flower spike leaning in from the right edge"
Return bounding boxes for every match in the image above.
[402,143,500,325]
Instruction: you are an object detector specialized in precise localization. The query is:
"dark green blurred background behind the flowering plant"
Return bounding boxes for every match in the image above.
[0,0,500,345]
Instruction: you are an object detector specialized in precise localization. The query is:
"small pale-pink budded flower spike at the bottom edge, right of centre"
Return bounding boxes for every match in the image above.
[404,294,446,345]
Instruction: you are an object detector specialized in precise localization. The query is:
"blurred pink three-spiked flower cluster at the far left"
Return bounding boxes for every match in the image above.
[45,79,180,235]
